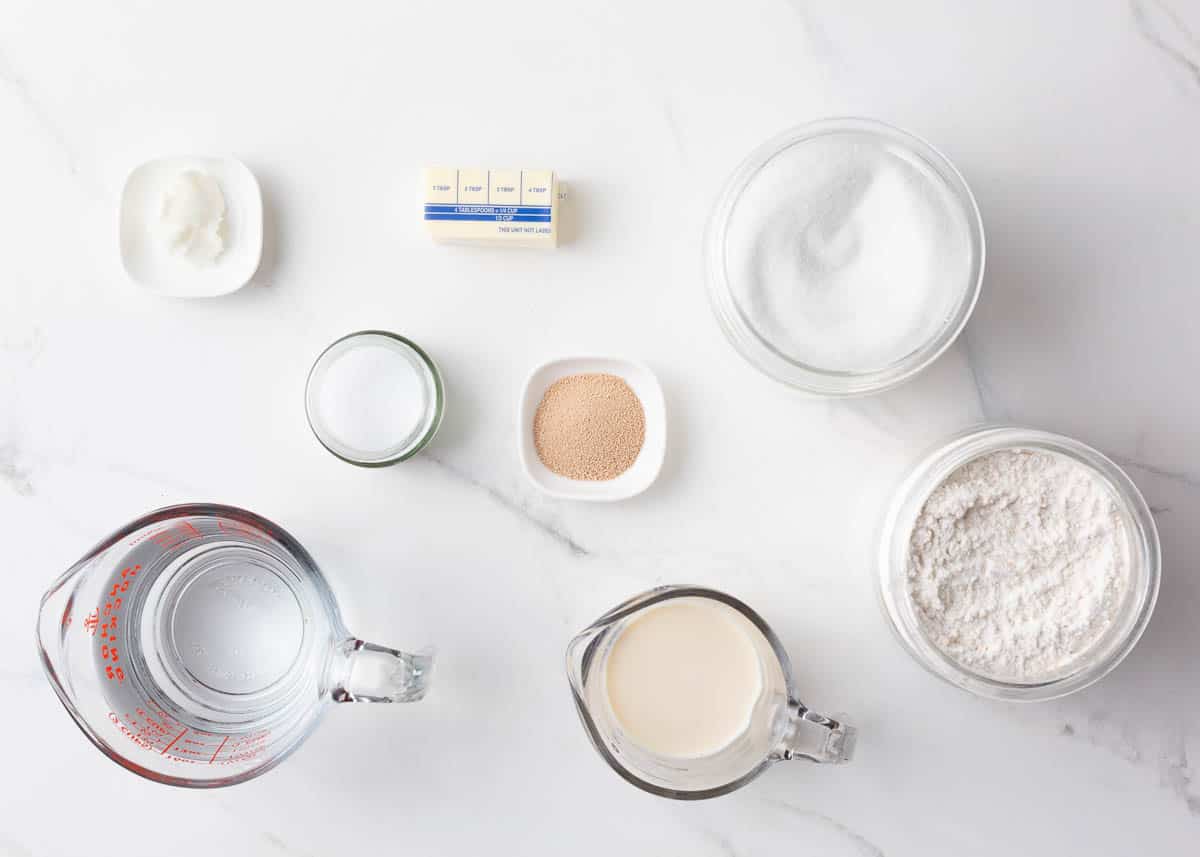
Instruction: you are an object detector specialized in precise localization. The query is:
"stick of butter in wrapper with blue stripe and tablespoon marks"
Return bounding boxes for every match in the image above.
[421,167,563,247]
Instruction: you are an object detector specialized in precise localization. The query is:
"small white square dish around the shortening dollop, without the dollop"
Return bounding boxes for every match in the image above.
[120,157,263,298]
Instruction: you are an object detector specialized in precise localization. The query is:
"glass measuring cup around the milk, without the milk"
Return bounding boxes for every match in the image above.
[566,586,854,801]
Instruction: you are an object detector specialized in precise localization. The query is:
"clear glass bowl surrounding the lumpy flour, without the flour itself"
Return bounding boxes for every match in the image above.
[878,425,1162,702]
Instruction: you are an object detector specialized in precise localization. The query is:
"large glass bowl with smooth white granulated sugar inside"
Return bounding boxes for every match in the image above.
[706,119,984,396]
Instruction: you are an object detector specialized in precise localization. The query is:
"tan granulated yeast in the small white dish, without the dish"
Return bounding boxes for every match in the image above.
[533,372,646,481]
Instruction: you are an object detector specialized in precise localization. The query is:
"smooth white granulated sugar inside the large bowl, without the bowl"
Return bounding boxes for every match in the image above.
[726,132,973,372]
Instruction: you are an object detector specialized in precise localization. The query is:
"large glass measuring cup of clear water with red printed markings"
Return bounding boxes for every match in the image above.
[37,504,432,787]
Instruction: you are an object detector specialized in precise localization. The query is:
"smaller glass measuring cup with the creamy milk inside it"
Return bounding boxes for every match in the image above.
[566,586,854,799]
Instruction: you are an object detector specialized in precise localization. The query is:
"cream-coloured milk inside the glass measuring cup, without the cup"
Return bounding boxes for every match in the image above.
[605,598,764,759]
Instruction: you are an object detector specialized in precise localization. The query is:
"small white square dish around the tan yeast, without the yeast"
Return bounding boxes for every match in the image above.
[517,356,667,502]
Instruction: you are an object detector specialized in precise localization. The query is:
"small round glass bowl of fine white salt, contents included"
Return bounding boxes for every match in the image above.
[305,330,445,467]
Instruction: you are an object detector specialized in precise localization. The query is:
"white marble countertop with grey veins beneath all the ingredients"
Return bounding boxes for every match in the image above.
[0,0,1200,857]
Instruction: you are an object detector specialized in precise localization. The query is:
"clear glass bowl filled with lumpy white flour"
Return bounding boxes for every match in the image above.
[880,426,1162,701]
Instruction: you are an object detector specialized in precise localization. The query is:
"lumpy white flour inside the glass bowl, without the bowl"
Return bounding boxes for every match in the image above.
[908,450,1130,682]
